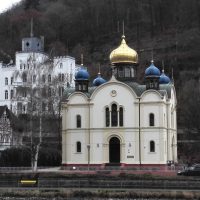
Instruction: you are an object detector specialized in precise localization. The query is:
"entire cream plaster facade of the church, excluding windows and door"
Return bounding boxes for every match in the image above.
[63,82,176,164]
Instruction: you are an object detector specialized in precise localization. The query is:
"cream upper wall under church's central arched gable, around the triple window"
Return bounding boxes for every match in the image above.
[91,83,138,128]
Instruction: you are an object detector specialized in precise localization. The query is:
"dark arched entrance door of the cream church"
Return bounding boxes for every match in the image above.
[109,137,120,163]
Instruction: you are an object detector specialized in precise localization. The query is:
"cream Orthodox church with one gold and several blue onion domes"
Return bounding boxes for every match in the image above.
[62,35,177,166]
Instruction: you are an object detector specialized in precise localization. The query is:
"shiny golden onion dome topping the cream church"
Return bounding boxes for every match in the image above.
[110,35,138,64]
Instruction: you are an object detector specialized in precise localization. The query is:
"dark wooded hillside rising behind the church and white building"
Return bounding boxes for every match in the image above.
[0,0,200,162]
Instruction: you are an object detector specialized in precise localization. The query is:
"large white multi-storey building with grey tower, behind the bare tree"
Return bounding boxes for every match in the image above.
[0,33,76,114]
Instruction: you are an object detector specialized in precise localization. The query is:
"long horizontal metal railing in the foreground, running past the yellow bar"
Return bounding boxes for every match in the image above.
[0,178,200,190]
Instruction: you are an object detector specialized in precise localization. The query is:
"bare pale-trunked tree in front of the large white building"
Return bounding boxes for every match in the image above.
[14,53,64,171]
